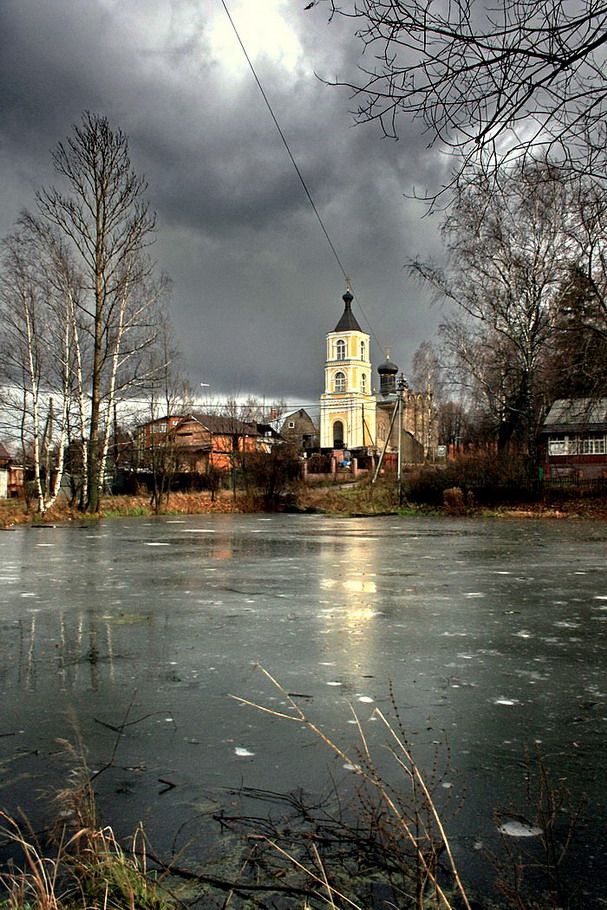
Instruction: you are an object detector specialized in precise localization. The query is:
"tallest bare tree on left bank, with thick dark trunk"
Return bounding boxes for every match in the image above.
[38,113,156,512]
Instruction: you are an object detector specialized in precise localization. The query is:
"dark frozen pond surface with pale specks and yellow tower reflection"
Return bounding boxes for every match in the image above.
[0,515,607,906]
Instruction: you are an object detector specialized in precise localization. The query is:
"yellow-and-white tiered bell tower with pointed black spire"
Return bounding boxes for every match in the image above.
[320,288,375,450]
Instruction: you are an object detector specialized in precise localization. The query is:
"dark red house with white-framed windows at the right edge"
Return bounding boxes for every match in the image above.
[539,398,607,479]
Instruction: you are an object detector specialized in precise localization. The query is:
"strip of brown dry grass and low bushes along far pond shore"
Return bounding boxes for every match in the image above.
[0,468,607,530]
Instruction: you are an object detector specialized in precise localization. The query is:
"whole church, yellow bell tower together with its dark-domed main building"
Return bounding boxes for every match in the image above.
[320,290,437,464]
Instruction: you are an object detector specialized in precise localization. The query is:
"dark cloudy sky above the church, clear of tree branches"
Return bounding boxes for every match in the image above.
[0,0,447,404]
